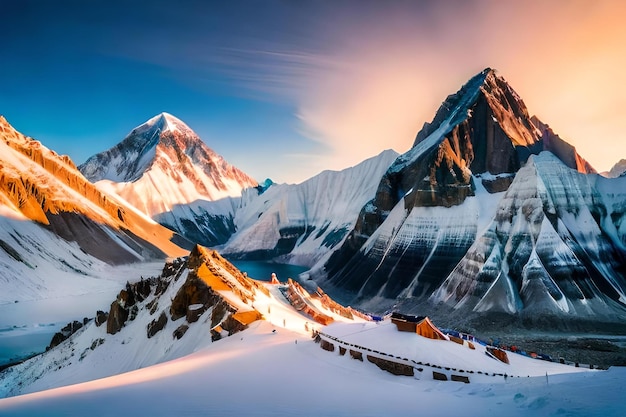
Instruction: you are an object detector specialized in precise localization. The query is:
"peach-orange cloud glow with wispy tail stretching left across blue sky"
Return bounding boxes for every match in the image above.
[95,0,626,176]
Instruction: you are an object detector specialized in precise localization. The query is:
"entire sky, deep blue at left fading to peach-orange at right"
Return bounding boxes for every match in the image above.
[0,0,626,182]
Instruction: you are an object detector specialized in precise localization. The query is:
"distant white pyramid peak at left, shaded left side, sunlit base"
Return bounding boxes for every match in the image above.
[79,113,257,221]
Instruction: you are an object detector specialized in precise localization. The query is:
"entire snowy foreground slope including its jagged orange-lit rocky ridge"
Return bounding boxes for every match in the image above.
[0,247,626,416]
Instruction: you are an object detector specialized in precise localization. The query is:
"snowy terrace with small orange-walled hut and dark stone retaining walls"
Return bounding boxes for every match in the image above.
[318,313,584,383]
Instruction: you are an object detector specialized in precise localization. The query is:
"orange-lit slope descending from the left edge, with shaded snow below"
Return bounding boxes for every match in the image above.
[0,117,183,302]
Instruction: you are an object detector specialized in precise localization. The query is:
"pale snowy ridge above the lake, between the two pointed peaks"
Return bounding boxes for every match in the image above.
[220,150,398,266]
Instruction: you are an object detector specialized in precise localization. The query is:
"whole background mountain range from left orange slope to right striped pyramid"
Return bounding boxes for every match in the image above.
[0,68,626,329]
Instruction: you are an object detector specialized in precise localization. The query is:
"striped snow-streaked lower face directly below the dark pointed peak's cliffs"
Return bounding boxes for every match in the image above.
[330,195,486,306]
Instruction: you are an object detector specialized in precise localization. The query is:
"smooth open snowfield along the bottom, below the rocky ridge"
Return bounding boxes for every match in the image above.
[0,321,626,417]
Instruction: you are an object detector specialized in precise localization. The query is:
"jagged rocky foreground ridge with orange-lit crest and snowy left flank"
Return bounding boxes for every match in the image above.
[0,246,366,398]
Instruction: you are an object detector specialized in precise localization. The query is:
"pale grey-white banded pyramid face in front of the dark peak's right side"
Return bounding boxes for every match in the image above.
[431,153,626,321]
